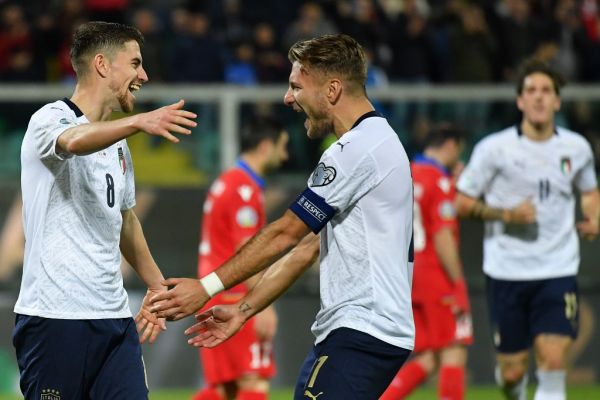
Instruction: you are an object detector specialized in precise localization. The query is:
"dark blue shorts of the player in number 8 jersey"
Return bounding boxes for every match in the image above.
[13,314,148,400]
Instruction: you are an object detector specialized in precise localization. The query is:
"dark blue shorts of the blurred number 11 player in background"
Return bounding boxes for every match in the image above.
[487,276,579,353]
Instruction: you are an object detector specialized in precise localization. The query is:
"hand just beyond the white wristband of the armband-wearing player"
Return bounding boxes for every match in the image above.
[150,278,210,321]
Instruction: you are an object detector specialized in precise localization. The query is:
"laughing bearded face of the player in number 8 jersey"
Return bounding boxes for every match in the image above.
[108,40,148,113]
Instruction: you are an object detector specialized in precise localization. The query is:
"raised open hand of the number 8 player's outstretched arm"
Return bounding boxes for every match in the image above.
[135,100,198,143]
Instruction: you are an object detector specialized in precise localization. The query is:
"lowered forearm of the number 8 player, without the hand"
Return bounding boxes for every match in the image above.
[119,210,164,288]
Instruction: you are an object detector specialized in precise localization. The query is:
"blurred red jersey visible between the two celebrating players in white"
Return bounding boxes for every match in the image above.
[198,162,266,297]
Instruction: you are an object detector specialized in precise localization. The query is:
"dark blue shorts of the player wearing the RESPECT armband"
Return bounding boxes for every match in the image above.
[294,328,410,400]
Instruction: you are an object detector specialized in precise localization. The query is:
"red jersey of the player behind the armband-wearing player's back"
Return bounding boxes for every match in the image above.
[411,157,458,302]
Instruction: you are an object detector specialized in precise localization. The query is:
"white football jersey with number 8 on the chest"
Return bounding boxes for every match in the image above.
[15,99,135,319]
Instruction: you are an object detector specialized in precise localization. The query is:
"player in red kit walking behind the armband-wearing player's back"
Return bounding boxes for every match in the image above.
[381,124,472,400]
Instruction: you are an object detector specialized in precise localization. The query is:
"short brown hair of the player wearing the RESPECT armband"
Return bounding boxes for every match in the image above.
[288,34,367,92]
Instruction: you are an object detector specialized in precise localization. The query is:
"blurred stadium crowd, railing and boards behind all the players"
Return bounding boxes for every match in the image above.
[0,0,600,398]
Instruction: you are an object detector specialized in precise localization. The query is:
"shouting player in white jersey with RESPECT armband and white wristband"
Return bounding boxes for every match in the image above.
[153,35,414,399]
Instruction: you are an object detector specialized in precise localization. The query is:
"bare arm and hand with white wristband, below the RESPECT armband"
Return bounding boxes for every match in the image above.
[151,210,310,320]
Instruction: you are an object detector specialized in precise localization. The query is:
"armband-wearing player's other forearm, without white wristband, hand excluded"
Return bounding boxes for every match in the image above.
[238,233,320,319]
